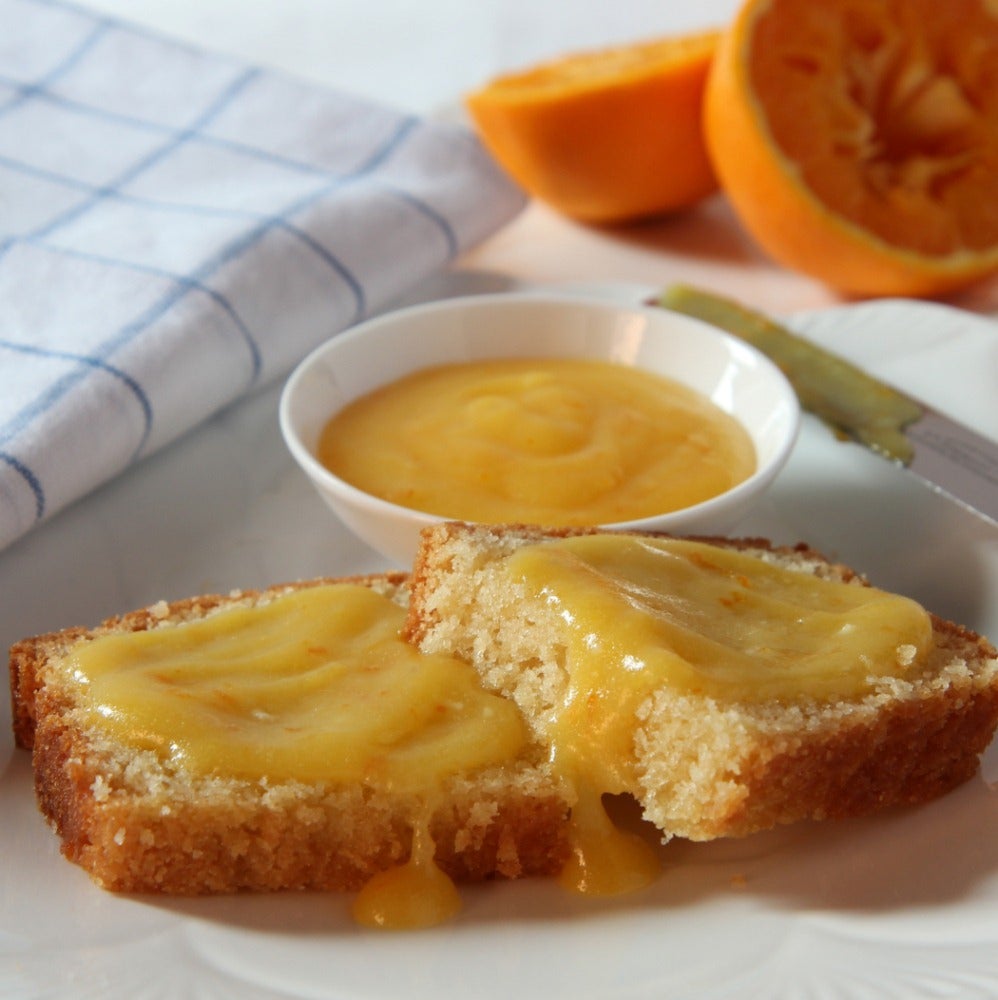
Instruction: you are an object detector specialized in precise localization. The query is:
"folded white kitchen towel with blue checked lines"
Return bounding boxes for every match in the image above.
[0,0,523,547]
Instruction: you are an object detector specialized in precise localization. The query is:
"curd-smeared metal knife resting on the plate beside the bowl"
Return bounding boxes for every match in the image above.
[650,285,998,526]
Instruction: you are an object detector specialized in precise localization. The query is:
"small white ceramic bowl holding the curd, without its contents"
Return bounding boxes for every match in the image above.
[280,293,800,566]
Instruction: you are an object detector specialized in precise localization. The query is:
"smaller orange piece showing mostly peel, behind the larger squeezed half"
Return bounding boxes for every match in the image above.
[465,32,719,223]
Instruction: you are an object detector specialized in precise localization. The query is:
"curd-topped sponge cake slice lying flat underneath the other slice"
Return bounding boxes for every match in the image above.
[10,575,568,908]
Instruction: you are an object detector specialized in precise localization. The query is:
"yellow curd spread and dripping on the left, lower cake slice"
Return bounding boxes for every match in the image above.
[70,583,527,927]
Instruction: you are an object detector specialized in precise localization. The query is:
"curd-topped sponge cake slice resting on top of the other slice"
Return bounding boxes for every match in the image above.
[406,523,998,840]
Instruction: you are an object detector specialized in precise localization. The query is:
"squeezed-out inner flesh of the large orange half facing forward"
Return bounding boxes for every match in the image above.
[747,0,998,256]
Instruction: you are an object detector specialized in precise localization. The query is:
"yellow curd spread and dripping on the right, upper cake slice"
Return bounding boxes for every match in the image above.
[505,534,933,894]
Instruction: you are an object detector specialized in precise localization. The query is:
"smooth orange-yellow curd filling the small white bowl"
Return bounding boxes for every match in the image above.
[318,358,756,526]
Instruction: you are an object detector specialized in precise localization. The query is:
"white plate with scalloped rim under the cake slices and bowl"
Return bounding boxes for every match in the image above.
[0,278,998,1000]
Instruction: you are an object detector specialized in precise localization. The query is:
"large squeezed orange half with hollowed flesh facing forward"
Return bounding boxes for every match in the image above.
[704,0,998,296]
